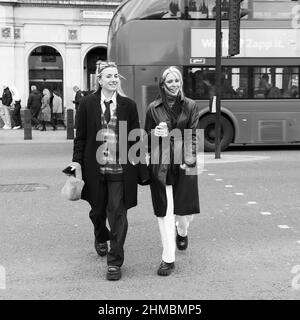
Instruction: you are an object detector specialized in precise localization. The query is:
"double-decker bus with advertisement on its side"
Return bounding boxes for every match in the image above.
[108,0,300,151]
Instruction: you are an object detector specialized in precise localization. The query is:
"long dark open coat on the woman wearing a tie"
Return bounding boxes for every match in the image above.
[73,89,149,209]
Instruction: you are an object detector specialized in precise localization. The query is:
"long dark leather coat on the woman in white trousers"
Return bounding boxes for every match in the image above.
[145,98,200,217]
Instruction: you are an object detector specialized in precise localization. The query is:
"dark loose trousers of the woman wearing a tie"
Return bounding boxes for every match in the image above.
[90,180,128,267]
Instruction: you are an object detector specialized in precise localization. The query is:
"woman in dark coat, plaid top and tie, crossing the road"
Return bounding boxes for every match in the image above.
[70,63,148,280]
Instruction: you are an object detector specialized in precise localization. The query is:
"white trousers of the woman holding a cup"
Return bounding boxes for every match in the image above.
[157,186,193,263]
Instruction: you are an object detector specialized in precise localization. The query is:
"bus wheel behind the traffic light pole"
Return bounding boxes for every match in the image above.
[198,114,233,151]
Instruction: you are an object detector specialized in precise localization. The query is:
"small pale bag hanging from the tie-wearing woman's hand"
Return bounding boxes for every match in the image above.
[61,167,84,201]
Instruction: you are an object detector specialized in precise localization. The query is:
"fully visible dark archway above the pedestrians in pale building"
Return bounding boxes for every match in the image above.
[28,46,63,97]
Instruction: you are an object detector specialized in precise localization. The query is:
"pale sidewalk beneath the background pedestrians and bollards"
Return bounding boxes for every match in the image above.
[0,129,75,144]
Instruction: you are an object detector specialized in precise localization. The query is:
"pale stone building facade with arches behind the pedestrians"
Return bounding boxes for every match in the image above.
[0,0,121,108]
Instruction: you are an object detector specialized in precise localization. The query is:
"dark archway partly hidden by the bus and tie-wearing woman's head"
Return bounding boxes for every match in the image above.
[84,47,107,91]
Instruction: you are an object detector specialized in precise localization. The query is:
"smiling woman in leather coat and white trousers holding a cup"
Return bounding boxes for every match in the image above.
[145,67,200,276]
